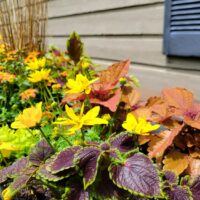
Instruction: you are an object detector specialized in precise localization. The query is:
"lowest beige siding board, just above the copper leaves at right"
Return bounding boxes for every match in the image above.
[94,60,200,100]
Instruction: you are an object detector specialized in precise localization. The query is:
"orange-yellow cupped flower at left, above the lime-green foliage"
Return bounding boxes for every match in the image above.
[11,102,42,129]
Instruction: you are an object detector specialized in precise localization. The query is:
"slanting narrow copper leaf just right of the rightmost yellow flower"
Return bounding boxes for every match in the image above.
[148,125,184,158]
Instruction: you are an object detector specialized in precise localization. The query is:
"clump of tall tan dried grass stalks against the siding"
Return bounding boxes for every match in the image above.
[0,0,47,51]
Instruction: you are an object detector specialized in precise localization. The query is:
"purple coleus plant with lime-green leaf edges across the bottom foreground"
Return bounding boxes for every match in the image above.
[0,132,164,200]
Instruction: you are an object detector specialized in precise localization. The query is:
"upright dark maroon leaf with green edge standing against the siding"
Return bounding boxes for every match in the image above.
[67,32,83,64]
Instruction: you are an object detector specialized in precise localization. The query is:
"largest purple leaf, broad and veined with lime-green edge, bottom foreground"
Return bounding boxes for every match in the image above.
[109,153,161,197]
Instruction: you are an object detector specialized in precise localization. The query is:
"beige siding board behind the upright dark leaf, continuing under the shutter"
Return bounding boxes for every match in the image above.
[47,37,200,70]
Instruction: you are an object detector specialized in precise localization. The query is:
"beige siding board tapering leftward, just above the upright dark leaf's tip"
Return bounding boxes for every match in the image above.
[47,5,164,36]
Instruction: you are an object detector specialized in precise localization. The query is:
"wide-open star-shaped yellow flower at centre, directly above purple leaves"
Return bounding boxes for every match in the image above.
[54,104,108,135]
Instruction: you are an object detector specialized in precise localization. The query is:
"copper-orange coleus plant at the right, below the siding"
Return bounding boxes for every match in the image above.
[135,88,200,176]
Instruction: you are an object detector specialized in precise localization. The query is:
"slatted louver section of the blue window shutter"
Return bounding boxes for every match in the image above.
[170,0,200,32]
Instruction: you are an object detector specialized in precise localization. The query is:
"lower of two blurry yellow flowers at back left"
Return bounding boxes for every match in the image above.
[28,69,51,83]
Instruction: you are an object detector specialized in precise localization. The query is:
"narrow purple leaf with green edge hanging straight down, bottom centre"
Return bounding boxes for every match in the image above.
[75,147,101,190]
